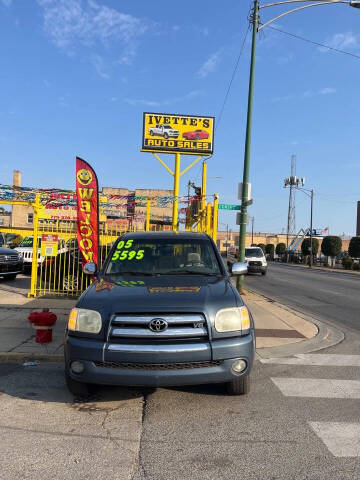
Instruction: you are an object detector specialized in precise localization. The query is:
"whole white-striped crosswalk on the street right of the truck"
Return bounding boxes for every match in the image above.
[260,354,360,457]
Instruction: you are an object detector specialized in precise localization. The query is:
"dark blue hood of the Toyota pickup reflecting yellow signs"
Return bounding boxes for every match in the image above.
[77,275,243,320]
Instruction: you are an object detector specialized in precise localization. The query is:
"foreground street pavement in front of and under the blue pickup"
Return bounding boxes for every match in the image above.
[0,354,360,480]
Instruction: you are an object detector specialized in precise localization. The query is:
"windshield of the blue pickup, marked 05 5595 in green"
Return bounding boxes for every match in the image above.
[105,237,222,275]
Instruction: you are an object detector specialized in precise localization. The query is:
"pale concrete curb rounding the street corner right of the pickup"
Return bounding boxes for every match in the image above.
[247,288,345,358]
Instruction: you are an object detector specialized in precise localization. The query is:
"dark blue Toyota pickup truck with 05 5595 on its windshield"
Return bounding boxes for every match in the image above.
[64,232,255,395]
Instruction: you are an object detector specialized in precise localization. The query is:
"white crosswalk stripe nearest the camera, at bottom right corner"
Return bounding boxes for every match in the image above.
[309,422,360,457]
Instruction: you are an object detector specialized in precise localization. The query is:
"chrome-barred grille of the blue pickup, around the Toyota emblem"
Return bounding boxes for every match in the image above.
[108,313,208,342]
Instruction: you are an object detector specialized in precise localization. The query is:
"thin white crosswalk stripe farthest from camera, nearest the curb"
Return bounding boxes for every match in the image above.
[260,353,360,367]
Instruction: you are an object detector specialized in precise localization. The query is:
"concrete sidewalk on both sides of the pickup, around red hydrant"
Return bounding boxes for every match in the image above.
[0,291,318,361]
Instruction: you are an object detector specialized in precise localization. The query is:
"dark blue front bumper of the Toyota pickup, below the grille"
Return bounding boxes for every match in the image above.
[65,332,255,387]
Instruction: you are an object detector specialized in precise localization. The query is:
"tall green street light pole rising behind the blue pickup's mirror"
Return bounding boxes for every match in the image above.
[236,0,259,293]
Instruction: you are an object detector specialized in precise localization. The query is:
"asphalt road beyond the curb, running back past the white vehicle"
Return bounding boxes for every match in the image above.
[245,263,360,333]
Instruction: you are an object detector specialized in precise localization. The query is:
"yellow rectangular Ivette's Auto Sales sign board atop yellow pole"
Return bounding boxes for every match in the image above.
[142,112,215,155]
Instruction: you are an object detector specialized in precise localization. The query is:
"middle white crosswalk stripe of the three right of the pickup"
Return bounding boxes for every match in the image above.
[271,377,360,399]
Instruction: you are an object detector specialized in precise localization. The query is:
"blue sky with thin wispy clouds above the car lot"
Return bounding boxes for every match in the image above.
[0,0,360,234]
